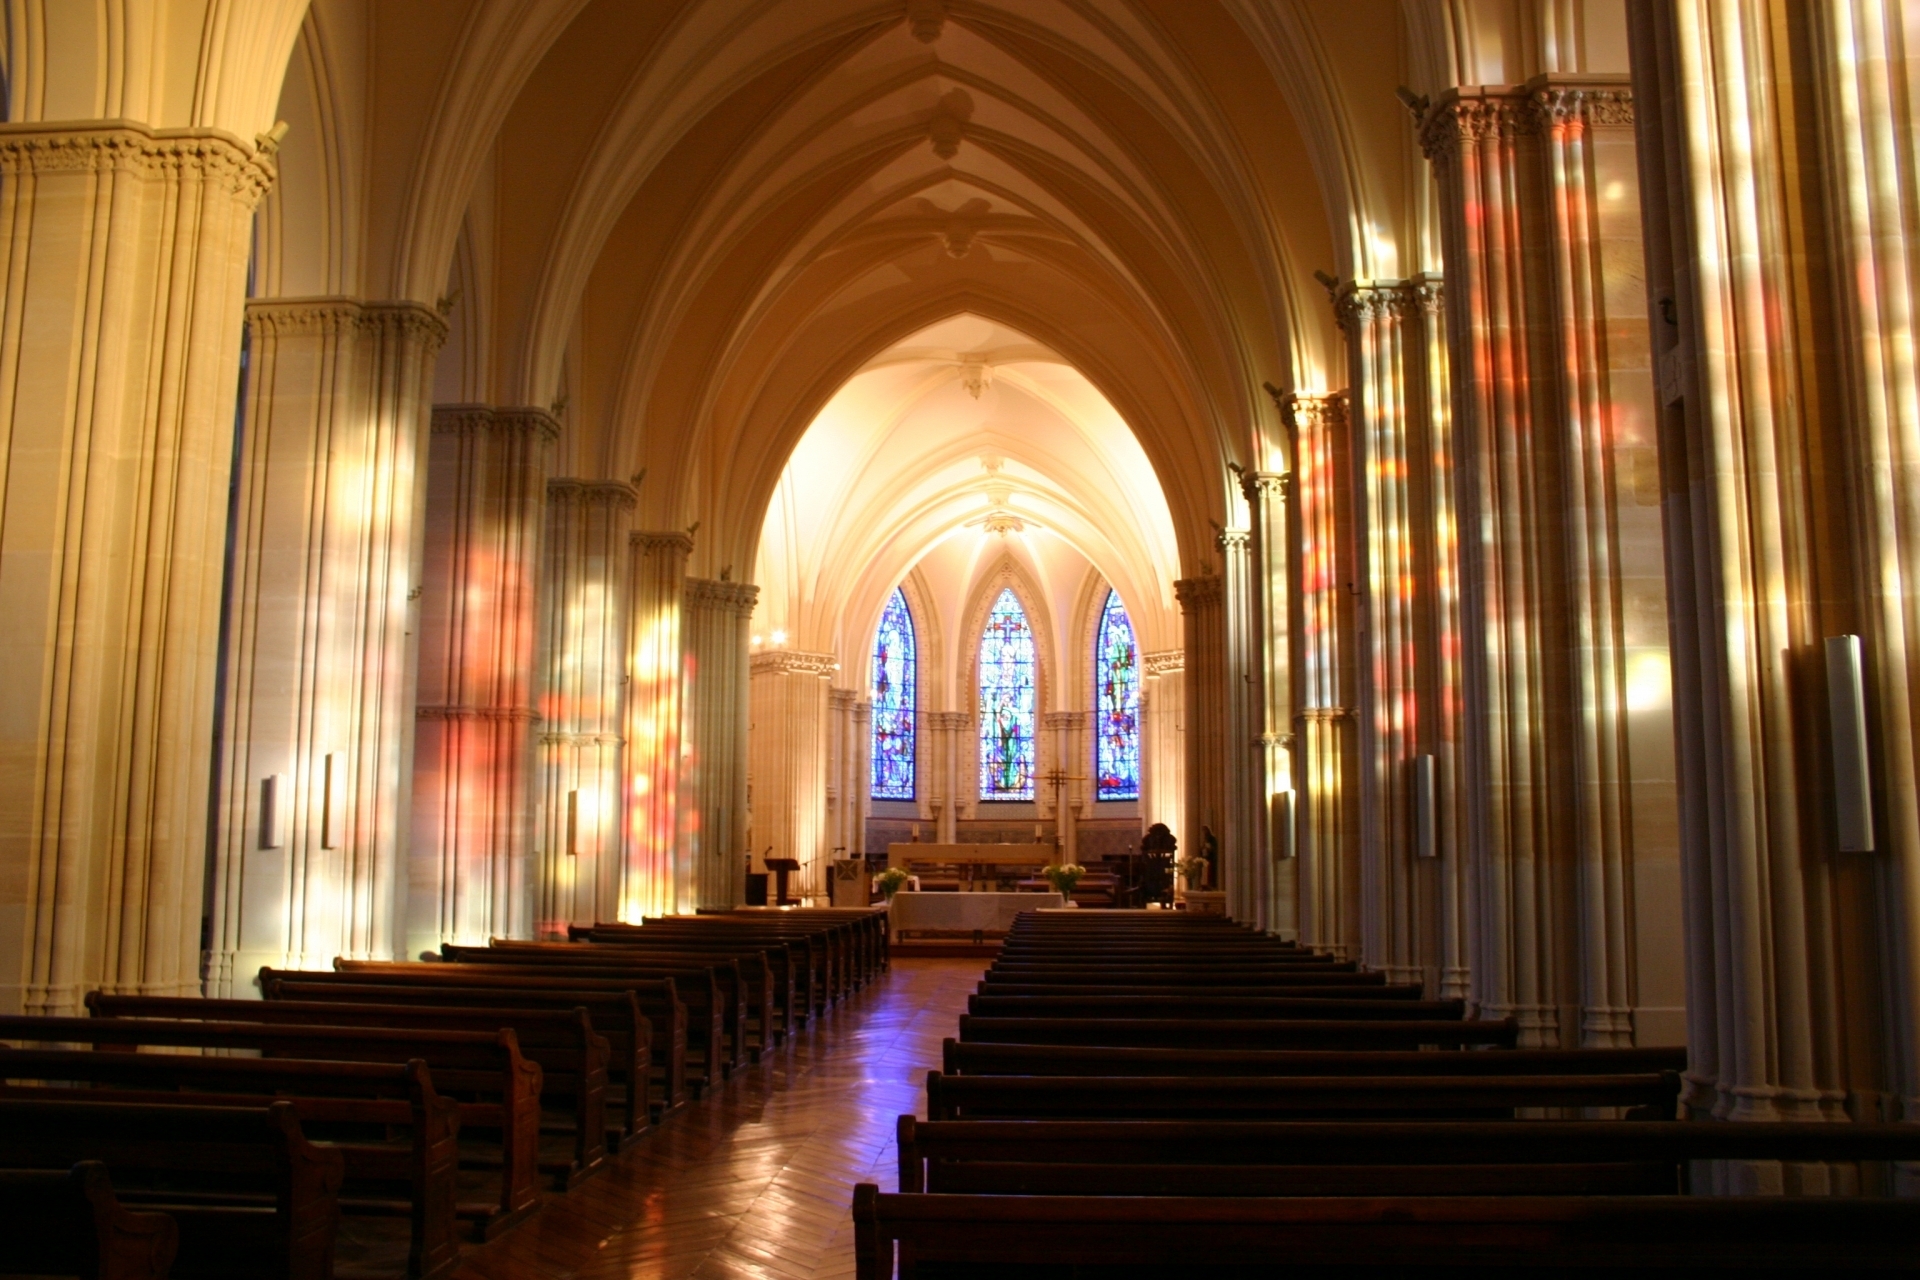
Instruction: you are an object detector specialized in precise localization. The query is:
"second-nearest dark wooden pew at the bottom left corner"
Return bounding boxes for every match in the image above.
[0,1098,344,1280]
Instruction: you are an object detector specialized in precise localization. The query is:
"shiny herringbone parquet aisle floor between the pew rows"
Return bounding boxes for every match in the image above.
[455,960,985,1280]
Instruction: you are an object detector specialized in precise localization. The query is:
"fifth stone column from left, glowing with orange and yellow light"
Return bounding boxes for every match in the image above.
[620,532,695,925]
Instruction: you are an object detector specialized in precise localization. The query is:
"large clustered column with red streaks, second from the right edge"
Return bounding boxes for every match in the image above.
[1421,75,1676,1046]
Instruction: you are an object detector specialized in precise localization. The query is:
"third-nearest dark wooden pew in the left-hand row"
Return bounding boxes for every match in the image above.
[0,1048,461,1280]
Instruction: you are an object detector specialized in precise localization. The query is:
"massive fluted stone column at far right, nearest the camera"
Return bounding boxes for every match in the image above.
[1628,0,1920,1143]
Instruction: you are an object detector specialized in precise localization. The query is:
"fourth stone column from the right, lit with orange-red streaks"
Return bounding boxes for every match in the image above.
[1286,395,1359,960]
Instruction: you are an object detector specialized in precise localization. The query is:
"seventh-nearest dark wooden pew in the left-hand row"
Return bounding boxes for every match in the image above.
[334,960,728,1098]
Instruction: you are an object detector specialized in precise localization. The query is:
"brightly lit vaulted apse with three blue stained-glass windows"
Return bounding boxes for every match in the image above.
[749,315,1183,890]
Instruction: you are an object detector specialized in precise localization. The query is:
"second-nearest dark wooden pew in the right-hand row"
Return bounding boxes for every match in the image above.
[897,1115,1920,1196]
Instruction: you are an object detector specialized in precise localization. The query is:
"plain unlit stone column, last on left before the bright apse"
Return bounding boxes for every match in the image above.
[680,578,760,910]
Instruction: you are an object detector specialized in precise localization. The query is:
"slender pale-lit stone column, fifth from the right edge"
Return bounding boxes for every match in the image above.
[1240,472,1300,938]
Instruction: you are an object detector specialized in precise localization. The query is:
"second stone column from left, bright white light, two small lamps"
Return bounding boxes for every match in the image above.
[207,297,445,996]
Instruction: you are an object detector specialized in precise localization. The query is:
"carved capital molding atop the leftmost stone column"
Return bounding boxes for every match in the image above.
[0,121,278,207]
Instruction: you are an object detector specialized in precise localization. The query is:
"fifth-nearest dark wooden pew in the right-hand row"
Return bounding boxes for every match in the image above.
[960,1013,1521,1050]
